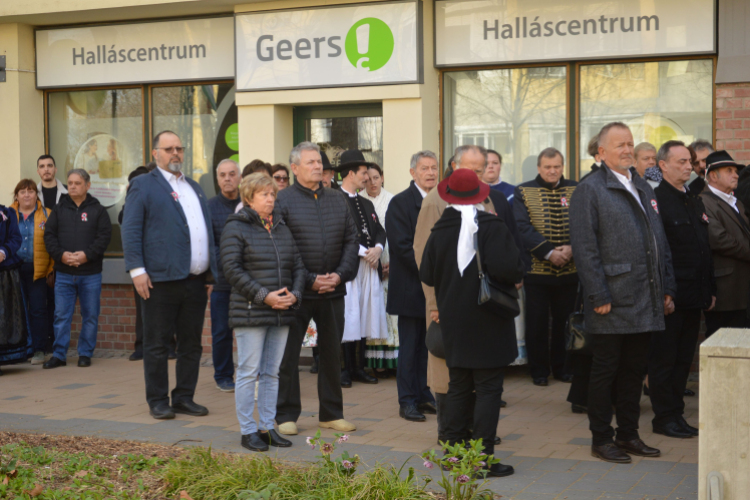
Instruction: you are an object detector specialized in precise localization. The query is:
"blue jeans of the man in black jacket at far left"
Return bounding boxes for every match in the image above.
[53,271,102,361]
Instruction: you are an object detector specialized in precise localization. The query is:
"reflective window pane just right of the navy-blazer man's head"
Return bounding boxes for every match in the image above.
[151,83,236,197]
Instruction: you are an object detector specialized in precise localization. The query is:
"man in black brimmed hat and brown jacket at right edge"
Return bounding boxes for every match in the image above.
[701,151,750,337]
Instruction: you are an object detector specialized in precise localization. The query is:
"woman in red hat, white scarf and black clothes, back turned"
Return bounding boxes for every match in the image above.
[419,169,523,476]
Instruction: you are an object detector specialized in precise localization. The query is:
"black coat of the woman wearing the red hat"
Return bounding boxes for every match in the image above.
[419,208,523,369]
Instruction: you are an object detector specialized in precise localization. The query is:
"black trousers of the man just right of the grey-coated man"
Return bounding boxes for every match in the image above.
[648,309,701,425]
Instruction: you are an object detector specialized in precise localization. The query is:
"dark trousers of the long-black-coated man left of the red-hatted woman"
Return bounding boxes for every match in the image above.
[396,316,435,406]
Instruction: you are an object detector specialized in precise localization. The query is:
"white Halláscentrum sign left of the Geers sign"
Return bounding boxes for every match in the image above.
[36,17,234,88]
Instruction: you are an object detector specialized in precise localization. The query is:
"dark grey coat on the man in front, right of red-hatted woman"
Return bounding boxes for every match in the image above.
[570,165,676,333]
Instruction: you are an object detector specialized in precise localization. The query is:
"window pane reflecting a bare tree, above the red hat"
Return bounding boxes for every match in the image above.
[443,66,567,184]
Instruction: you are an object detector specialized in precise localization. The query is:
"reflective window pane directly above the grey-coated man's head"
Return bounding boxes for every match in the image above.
[579,59,713,176]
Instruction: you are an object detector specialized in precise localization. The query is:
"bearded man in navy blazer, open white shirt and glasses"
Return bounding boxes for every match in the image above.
[122,131,217,419]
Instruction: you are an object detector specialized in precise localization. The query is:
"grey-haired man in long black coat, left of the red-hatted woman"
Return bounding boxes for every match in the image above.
[385,151,439,422]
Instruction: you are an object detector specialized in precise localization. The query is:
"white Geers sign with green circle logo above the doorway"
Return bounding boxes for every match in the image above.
[235,2,421,90]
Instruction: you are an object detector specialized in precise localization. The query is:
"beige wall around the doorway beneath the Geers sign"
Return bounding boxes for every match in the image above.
[235,0,440,193]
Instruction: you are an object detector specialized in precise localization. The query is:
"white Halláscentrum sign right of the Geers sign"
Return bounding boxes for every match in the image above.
[435,0,715,66]
